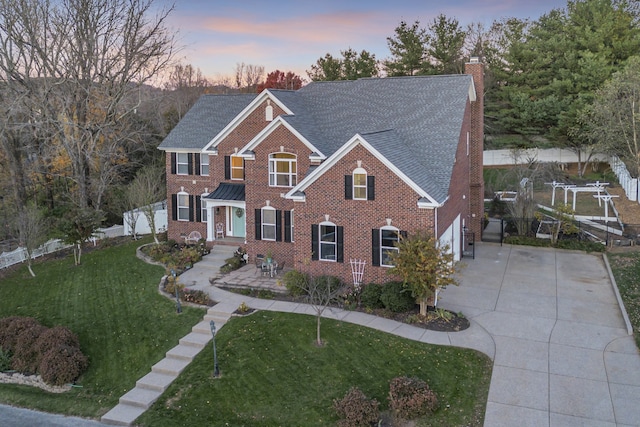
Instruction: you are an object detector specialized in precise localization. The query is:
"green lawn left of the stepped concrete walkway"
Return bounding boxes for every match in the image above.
[0,241,205,418]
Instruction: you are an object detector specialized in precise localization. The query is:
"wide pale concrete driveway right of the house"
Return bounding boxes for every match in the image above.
[440,243,640,427]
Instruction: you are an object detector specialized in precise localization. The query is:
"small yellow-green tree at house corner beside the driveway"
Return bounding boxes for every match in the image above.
[389,232,458,316]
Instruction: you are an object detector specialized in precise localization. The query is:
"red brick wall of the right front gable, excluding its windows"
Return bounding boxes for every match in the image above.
[294,145,434,283]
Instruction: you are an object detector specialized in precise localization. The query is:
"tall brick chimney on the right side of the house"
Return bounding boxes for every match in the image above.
[464,57,484,241]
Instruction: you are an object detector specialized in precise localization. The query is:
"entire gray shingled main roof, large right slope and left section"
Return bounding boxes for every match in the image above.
[160,74,472,202]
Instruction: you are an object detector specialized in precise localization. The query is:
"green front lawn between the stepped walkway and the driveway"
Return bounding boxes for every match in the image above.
[136,312,492,427]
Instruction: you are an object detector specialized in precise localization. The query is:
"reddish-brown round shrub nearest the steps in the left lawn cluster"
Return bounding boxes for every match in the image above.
[39,344,88,385]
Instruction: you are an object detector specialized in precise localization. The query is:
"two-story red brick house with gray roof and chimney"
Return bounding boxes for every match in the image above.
[159,59,484,283]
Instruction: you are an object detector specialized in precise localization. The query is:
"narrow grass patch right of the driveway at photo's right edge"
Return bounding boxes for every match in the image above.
[608,251,640,348]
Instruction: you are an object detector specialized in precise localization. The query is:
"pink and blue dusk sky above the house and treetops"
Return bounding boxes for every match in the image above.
[162,0,567,81]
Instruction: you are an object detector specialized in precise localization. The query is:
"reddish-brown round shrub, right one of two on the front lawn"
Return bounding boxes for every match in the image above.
[389,377,438,420]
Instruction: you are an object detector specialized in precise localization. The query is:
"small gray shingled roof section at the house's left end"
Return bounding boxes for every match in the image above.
[158,94,256,150]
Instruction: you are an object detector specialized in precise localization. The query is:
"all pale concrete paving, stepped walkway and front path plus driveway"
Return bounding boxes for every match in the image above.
[102,244,640,427]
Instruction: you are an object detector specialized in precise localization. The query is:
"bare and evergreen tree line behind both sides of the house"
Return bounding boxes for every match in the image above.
[0,0,640,276]
